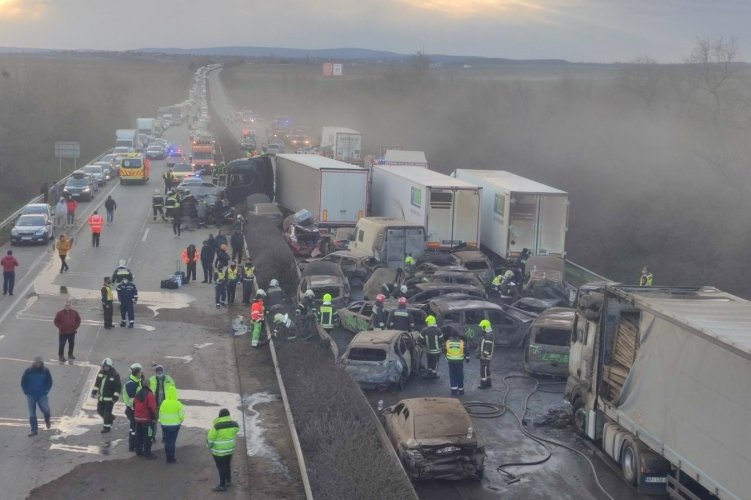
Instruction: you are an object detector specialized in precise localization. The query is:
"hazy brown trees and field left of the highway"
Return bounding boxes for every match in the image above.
[0,53,192,214]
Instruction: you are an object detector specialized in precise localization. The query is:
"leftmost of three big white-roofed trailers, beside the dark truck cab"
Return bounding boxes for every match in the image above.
[275,154,368,228]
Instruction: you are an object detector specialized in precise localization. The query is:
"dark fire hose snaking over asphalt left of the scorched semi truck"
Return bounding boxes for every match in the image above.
[464,375,615,500]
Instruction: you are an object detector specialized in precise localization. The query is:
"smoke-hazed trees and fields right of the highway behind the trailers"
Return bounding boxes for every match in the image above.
[225,39,751,296]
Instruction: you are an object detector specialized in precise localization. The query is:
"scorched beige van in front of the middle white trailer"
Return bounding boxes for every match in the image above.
[349,217,425,269]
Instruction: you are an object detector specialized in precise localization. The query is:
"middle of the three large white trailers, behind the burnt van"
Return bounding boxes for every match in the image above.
[371,165,482,248]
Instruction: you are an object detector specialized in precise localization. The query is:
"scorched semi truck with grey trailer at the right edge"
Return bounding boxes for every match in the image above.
[565,282,751,500]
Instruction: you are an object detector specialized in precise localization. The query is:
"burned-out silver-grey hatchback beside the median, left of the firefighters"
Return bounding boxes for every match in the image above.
[340,330,422,389]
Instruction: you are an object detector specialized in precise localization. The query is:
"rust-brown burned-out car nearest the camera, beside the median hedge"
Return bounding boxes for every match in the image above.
[383,398,485,480]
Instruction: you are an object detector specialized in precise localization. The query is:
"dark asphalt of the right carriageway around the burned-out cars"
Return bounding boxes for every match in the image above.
[208,71,639,500]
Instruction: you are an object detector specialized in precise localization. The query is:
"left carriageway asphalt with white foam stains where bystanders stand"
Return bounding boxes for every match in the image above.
[0,112,299,499]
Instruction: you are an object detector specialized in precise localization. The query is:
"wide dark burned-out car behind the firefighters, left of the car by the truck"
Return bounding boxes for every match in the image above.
[428,299,536,346]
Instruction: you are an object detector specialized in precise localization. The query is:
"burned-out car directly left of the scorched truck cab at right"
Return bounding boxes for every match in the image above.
[524,307,575,377]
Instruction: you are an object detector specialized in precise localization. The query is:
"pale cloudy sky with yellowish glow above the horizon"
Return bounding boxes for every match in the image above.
[0,0,751,63]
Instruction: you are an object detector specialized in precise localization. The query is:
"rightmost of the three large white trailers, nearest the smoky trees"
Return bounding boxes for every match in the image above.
[451,169,569,259]
